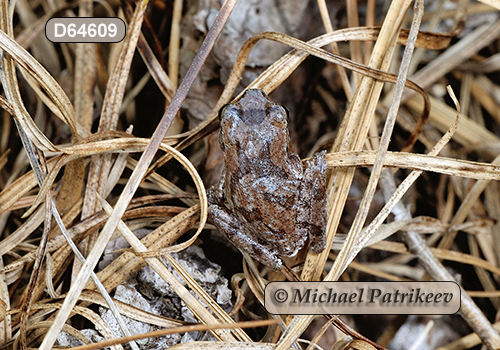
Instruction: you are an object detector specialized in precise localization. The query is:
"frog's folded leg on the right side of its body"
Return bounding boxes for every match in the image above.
[296,151,326,253]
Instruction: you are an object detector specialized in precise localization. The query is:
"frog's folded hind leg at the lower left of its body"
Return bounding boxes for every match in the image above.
[208,205,282,270]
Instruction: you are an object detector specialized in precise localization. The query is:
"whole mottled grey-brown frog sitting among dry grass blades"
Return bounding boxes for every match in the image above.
[208,89,326,270]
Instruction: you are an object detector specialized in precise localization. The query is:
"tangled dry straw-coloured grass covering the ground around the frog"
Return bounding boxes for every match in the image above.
[0,0,500,350]
